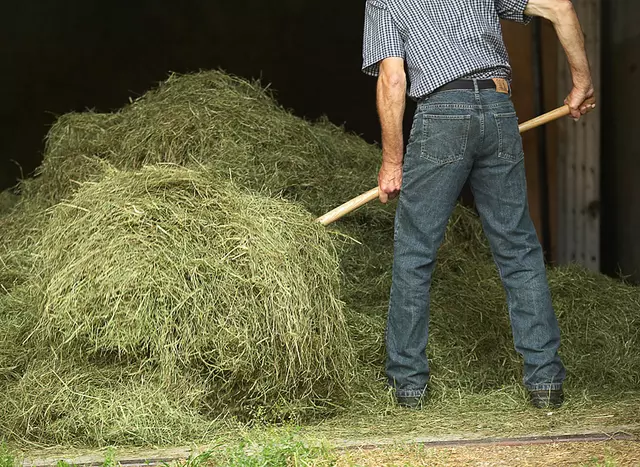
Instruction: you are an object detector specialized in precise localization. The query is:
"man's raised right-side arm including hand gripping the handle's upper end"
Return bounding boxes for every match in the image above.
[524,0,596,119]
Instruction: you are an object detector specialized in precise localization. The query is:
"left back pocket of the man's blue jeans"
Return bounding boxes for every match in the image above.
[422,114,471,164]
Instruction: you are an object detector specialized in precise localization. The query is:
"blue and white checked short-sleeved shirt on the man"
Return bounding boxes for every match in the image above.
[362,0,530,99]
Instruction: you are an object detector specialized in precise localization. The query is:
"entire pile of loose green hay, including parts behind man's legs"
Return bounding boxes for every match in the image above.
[0,72,640,445]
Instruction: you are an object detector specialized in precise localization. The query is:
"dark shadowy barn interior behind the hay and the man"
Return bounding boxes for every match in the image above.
[0,0,640,281]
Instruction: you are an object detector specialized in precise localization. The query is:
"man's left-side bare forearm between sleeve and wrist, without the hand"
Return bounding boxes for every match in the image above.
[377,71,407,164]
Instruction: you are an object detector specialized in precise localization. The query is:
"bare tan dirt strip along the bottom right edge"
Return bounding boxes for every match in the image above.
[336,441,640,467]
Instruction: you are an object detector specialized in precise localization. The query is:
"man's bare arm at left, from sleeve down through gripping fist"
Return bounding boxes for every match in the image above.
[377,57,407,203]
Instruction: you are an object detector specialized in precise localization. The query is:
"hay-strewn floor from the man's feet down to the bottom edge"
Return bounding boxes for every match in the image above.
[15,394,640,467]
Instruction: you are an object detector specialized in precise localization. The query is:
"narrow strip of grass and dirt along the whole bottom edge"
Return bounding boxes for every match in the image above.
[21,436,640,467]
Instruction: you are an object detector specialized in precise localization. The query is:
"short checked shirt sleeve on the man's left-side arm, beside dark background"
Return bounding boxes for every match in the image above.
[362,0,404,76]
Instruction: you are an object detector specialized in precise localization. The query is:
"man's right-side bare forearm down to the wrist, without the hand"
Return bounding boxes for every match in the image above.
[524,0,592,90]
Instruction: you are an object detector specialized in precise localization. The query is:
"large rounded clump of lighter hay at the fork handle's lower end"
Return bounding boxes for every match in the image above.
[20,166,354,416]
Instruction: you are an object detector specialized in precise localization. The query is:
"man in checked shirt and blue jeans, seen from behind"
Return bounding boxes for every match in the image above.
[363,0,595,408]
